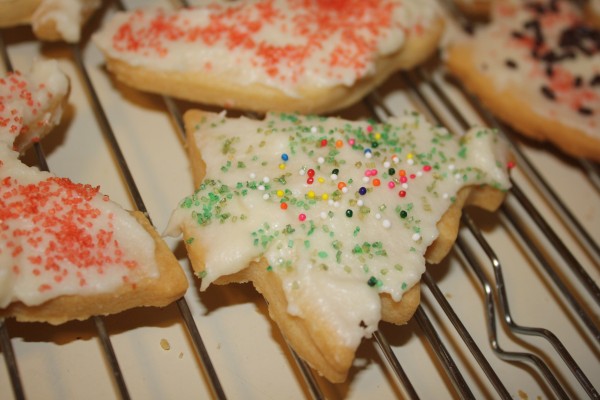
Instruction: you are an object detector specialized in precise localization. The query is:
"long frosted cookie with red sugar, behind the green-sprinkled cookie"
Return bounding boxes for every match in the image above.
[94,0,443,113]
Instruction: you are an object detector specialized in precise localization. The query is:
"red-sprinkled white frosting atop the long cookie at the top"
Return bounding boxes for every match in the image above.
[94,0,436,95]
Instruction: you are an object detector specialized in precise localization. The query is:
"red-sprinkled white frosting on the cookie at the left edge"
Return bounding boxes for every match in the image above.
[0,61,158,307]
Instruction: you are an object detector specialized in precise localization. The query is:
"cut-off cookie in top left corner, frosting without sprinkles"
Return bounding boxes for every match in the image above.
[0,0,102,43]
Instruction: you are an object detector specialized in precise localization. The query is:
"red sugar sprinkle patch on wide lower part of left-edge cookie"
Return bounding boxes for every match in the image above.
[0,177,138,292]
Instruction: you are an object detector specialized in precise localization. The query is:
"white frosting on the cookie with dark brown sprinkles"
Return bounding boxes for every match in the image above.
[458,1,600,139]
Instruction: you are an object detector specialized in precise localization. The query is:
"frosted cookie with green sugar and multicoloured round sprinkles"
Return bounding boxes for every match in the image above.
[167,111,509,382]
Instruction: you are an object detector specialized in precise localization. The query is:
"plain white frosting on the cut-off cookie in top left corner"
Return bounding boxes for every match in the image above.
[31,0,101,42]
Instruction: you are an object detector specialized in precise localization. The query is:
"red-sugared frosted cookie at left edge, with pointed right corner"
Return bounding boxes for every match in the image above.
[0,61,187,324]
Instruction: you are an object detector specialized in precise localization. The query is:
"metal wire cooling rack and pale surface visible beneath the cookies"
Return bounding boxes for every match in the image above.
[0,0,600,399]
